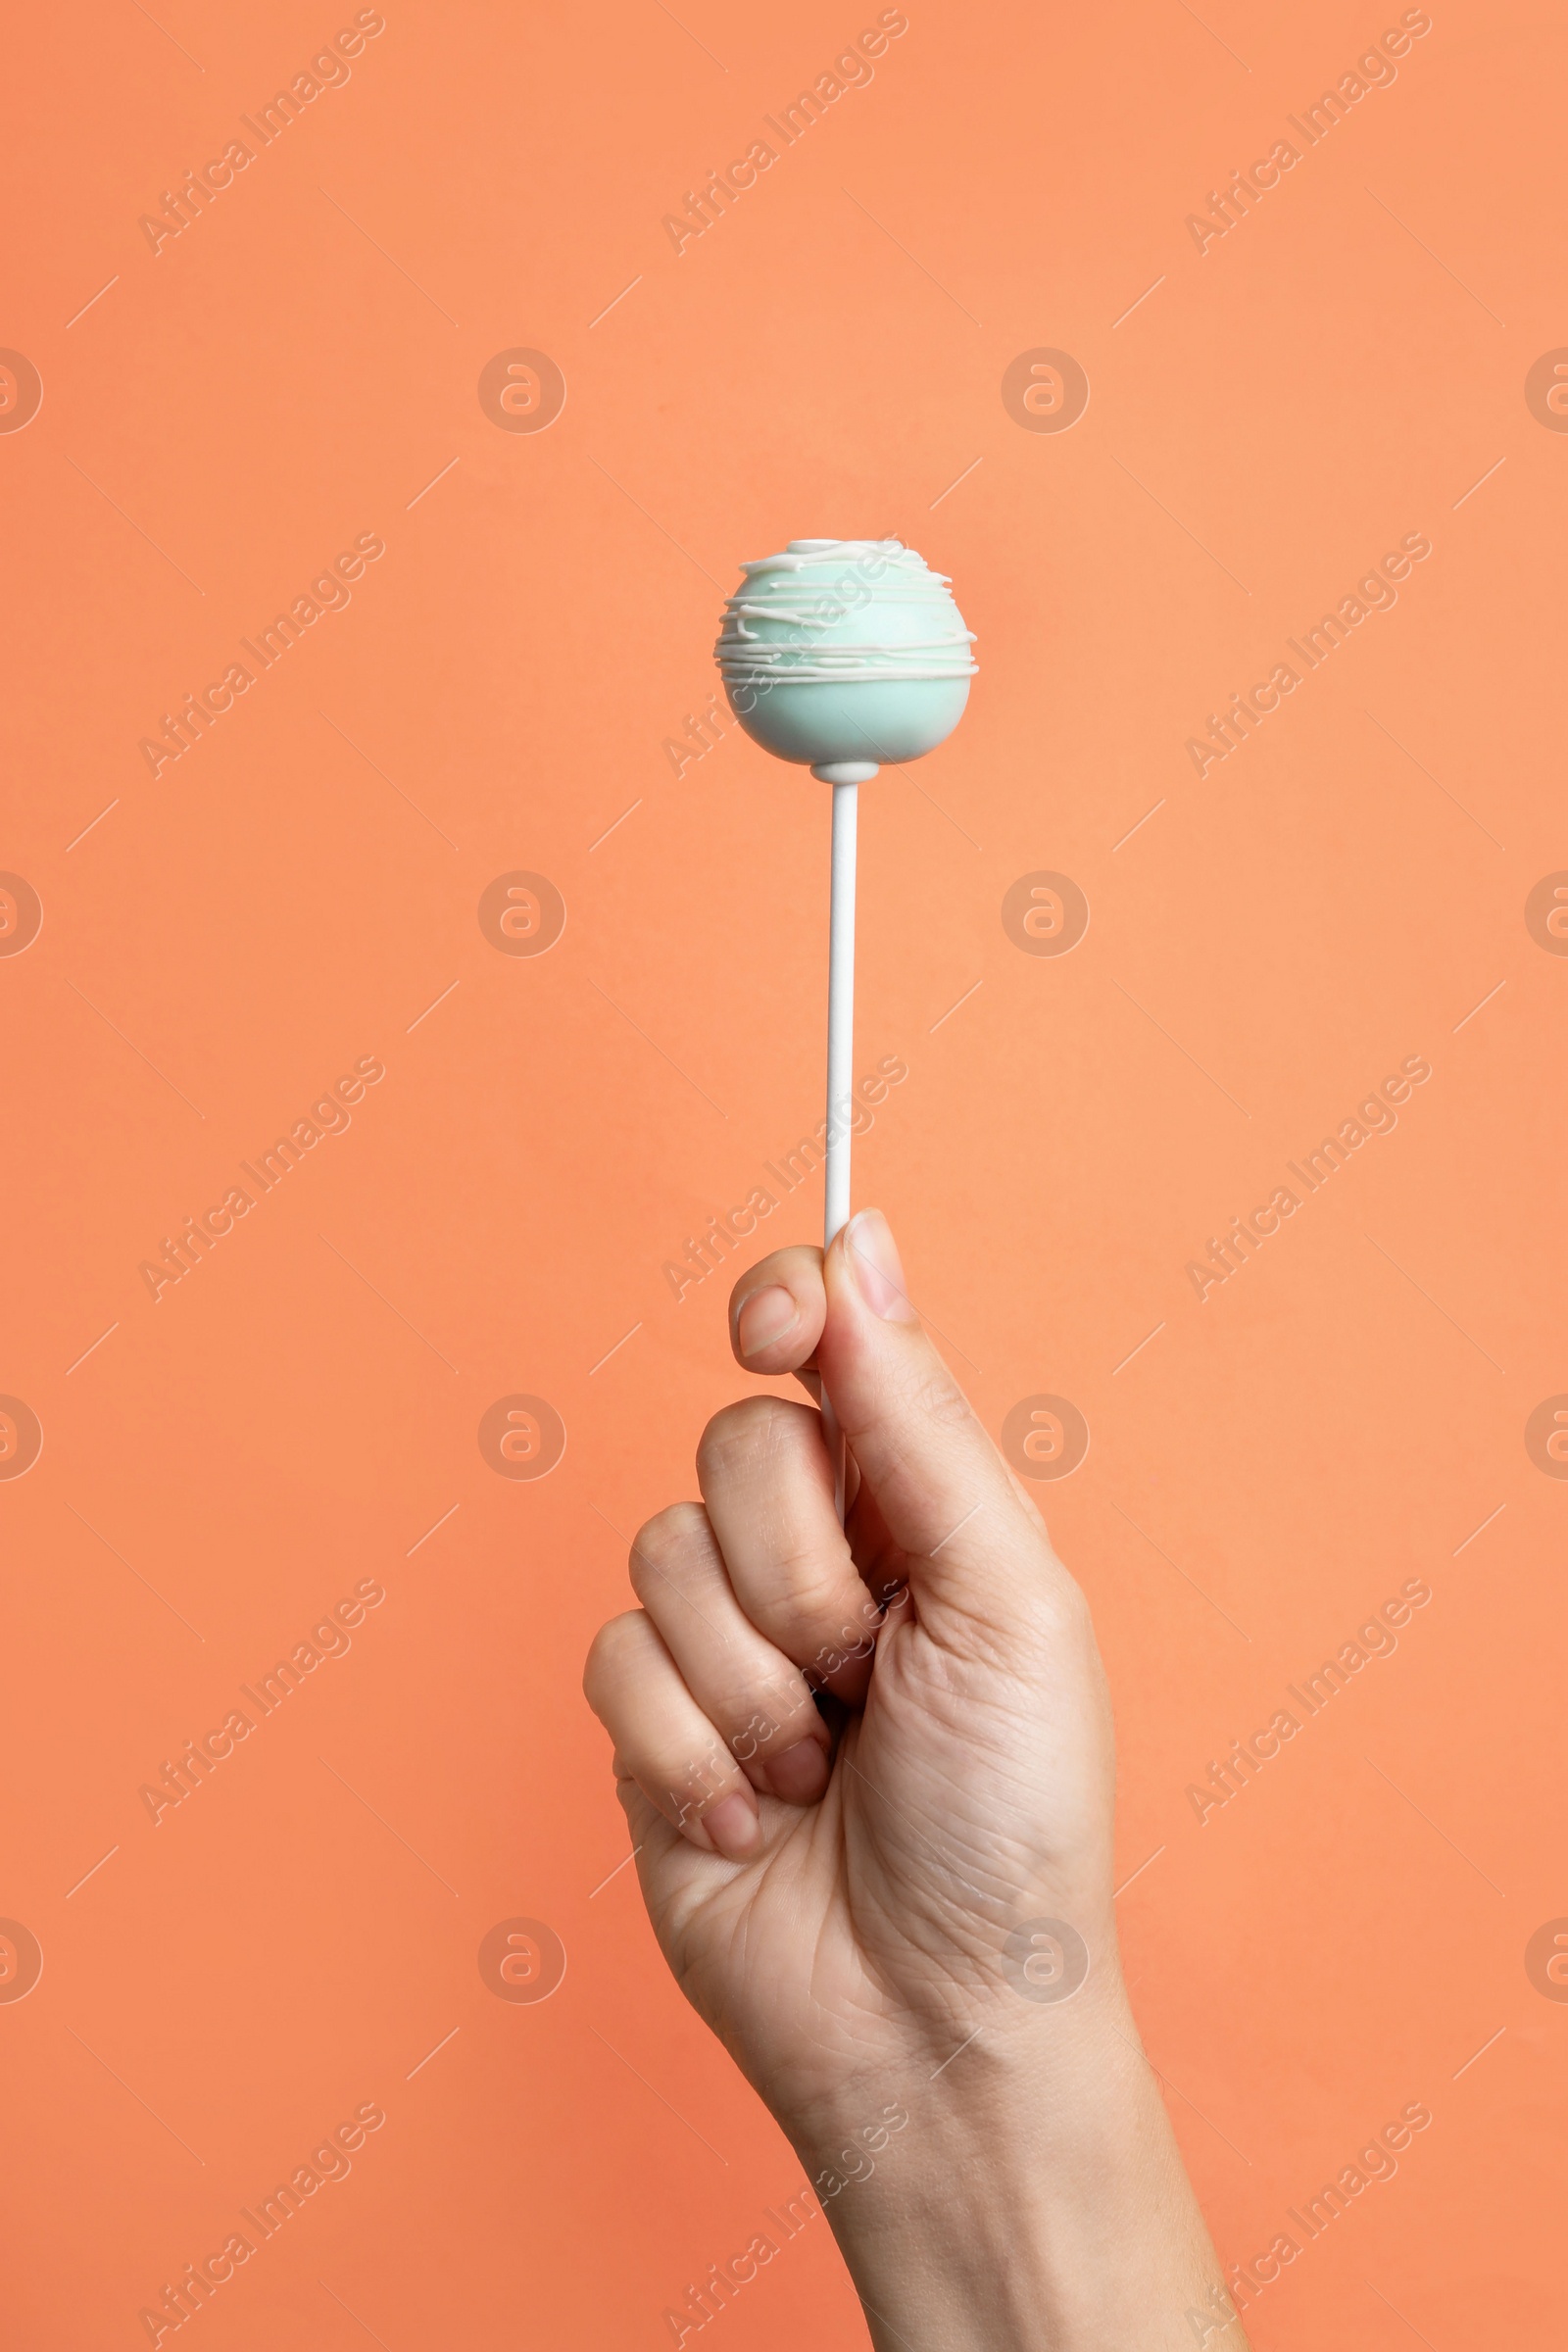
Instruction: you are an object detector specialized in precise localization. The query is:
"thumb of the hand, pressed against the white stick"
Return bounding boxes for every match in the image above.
[815,1209,1067,1625]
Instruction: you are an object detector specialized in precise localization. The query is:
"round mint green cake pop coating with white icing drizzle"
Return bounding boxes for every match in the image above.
[714,539,976,766]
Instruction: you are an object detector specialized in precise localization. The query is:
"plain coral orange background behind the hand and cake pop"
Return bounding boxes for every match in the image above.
[0,0,1568,2352]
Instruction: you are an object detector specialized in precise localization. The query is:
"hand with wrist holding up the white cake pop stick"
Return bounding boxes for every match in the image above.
[585,1211,1246,2352]
